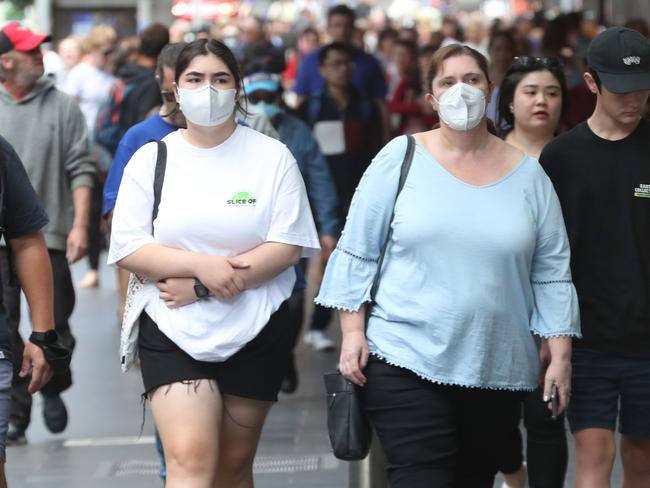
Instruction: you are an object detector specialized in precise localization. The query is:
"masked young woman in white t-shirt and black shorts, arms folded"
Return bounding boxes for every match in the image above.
[109,40,318,488]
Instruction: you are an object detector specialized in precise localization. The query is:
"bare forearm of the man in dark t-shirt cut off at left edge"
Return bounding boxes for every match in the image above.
[9,231,54,332]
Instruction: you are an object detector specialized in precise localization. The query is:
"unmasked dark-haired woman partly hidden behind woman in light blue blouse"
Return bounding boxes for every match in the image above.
[497,56,569,488]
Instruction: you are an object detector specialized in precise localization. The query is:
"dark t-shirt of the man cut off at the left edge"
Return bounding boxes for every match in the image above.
[0,137,48,353]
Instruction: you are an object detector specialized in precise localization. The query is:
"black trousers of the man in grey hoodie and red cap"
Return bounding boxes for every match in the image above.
[0,248,75,429]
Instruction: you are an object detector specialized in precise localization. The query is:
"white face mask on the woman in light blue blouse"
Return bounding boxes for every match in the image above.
[434,83,485,131]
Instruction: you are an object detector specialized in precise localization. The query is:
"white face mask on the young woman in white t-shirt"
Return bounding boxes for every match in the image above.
[178,85,237,127]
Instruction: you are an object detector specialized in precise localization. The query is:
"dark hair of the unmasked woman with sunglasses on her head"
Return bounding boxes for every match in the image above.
[497,62,569,130]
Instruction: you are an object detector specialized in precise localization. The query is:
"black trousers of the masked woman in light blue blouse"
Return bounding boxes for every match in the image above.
[362,357,523,488]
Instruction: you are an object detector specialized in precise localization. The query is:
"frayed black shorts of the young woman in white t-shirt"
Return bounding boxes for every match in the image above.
[138,302,293,401]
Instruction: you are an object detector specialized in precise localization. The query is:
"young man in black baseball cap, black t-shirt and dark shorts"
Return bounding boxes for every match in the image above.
[540,27,650,488]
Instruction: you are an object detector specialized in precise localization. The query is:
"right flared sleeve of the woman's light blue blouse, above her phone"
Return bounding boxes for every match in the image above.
[530,175,581,338]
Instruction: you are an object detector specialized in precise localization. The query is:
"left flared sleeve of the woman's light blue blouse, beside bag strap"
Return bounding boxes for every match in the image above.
[315,136,407,312]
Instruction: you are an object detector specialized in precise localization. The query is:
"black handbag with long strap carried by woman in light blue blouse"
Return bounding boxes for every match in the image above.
[324,136,415,461]
